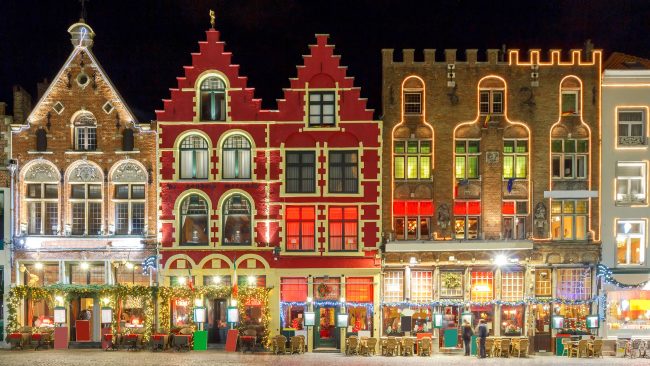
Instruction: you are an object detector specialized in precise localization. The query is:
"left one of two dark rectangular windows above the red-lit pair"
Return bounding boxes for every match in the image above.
[286,151,316,193]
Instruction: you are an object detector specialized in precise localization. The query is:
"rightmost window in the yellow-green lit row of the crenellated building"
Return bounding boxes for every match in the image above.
[551,139,589,179]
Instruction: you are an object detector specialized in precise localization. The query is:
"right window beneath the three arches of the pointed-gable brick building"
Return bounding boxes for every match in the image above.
[113,183,145,235]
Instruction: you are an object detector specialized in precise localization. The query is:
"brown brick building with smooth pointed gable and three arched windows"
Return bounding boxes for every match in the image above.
[11,20,157,340]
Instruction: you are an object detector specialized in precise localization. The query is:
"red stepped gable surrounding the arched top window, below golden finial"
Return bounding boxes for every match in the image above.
[156,29,261,122]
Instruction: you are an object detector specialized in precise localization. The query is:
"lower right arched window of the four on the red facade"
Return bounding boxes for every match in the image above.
[222,194,252,245]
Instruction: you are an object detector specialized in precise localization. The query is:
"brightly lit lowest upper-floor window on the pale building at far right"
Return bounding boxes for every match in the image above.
[616,220,646,264]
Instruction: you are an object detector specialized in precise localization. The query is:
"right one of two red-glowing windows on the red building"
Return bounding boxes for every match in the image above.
[328,207,359,252]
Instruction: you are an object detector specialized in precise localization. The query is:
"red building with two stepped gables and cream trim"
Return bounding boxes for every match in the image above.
[157,22,381,350]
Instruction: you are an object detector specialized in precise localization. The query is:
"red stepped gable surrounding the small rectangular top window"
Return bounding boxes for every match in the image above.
[276,34,373,121]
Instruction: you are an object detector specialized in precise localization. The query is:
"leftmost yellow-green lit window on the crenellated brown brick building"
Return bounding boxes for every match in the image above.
[393,140,431,179]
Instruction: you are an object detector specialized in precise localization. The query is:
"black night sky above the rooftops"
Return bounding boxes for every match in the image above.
[0,0,650,121]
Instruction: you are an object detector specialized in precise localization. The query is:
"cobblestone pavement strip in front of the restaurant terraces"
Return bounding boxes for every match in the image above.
[0,349,650,366]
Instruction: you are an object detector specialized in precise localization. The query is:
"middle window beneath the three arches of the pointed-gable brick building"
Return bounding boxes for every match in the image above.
[70,184,102,235]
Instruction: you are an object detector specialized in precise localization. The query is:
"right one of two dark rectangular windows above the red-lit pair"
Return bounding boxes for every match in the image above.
[329,151,359,193]
